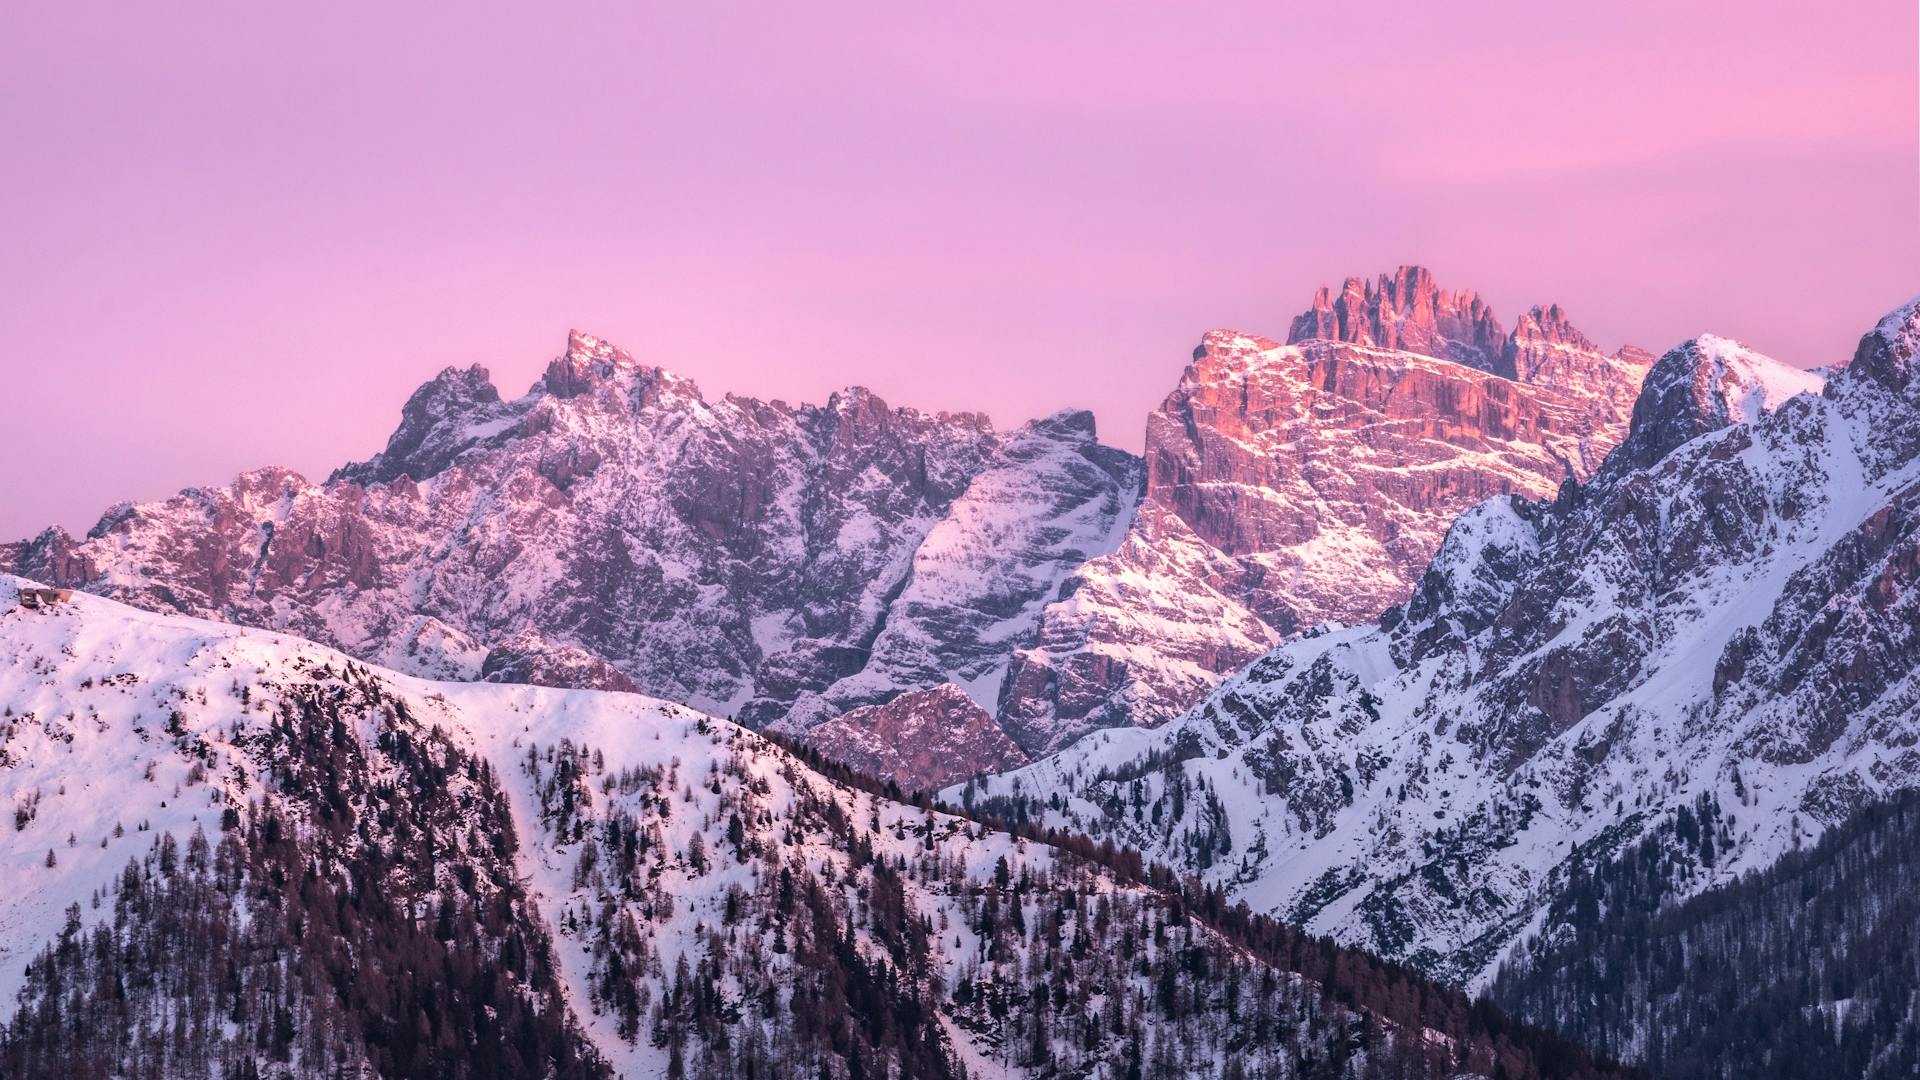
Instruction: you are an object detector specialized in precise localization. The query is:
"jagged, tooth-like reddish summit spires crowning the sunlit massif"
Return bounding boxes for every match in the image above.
[1286,265,1511,375]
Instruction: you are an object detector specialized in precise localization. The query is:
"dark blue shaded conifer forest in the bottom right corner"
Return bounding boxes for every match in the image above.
[1492,792,1920,1080]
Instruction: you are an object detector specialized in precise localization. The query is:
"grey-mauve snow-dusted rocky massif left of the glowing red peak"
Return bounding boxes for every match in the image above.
[0,332,1139,728]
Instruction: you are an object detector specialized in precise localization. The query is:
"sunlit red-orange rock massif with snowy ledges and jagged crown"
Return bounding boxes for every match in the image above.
[1000,267,1651,753]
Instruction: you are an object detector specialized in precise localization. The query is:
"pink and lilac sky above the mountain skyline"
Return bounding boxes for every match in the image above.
[0,0,1920,540]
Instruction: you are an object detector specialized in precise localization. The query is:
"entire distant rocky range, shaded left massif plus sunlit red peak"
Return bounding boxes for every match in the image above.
[0,267,1640,784]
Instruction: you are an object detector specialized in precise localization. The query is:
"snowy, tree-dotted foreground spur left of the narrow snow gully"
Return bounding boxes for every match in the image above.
[0,577,605,1078]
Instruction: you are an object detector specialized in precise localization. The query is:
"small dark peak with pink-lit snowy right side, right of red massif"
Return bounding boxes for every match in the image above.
[1607,334,1824,475]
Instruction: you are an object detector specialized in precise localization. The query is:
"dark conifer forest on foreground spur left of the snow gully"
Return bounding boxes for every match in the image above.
[0,663,607,1080]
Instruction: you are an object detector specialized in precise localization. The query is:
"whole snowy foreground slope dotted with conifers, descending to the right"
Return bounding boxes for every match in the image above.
[0,578,1609,1080]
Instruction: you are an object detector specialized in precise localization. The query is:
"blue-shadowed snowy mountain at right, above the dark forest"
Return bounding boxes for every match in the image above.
[956,302,1920,982]
